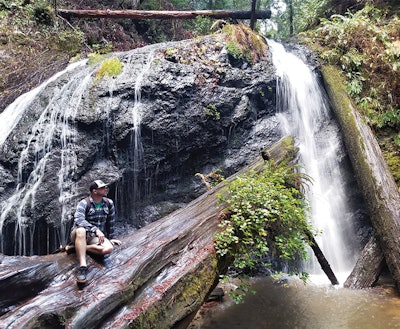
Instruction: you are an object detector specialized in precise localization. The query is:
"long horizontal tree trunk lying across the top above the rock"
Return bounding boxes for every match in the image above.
[57,9,271,19]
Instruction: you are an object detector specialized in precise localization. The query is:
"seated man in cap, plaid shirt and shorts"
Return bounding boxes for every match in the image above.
[66,180,121,284]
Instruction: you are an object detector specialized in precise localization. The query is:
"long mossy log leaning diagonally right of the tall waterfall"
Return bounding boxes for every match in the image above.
[322,66,400,291]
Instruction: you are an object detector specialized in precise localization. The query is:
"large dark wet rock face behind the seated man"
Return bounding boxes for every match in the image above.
[0,38,280,254]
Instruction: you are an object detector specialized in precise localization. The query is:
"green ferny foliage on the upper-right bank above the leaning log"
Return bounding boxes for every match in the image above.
[307,6,400,133]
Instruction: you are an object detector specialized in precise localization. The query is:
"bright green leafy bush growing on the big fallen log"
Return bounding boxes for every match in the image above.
[215,162,312,300]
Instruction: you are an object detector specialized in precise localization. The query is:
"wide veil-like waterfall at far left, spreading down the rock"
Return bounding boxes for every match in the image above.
[0,61,93,255]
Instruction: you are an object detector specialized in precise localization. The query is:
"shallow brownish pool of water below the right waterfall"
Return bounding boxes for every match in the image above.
[188,278,400,329]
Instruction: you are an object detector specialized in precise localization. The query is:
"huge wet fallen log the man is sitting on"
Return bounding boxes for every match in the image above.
[0,135,338,329]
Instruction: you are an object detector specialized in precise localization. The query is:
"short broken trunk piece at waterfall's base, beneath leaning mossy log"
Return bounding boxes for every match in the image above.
[343,236,385,289]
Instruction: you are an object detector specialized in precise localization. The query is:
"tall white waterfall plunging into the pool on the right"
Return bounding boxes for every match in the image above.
[268,41,357,283]
